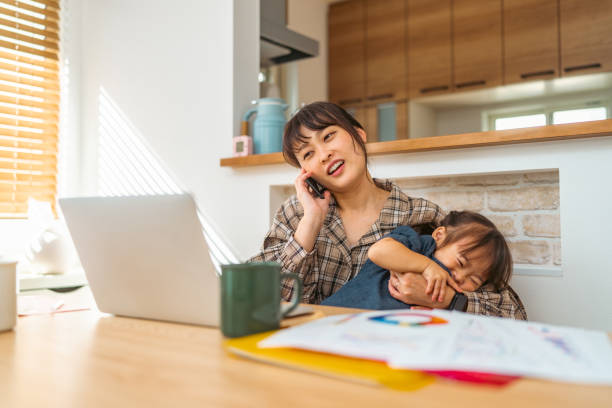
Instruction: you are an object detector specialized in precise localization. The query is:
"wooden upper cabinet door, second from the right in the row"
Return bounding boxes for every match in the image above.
[503,0,559,84]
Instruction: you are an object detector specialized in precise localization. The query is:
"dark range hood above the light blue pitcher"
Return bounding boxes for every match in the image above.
[259,0,319,67]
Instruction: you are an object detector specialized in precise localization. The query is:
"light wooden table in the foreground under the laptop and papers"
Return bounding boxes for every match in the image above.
[0,306,612,408]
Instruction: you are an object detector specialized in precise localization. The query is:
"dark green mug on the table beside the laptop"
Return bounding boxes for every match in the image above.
[221,262,302,337]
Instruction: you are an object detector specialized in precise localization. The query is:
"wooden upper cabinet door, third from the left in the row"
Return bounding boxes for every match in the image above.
[407,0,452,97]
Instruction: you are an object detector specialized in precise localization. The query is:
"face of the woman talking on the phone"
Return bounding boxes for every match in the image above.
[296,126,366,192]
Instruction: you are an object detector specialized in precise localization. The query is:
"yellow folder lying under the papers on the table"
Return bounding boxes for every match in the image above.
[224,332,435,391]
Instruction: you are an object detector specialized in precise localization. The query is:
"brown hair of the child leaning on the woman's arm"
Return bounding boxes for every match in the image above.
[440,211,512,290]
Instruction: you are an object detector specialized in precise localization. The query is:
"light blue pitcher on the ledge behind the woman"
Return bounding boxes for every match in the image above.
[242,98,289,154]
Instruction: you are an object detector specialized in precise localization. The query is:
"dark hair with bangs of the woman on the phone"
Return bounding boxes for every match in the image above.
[283,102,368,167]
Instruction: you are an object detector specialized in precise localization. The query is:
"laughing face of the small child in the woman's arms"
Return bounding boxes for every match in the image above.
[432,227,491,292]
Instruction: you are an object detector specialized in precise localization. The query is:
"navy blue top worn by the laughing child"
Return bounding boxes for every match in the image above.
[321,225,450,310]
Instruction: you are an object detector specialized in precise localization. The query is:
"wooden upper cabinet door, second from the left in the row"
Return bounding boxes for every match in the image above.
[366,0,406,101]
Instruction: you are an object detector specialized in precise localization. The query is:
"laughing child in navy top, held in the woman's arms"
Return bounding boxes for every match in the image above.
[321,211,512,310]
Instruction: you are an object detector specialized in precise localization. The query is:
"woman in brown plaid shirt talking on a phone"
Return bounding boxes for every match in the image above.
[250,102,527,319]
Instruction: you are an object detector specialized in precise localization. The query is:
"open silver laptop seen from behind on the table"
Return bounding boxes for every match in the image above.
[59,194,220,327]
